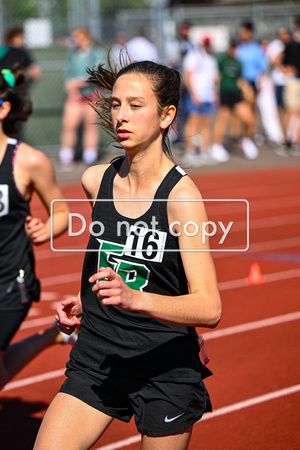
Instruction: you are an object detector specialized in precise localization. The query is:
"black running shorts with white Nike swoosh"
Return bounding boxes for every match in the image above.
[60,370,212,436]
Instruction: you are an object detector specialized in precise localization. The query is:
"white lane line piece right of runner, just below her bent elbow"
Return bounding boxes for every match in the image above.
[203,311,300,341]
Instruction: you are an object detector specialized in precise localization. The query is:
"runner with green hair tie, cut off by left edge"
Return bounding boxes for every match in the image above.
[0,69,70,389]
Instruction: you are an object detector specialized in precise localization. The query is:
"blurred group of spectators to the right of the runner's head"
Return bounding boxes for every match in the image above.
[162,16,300,166]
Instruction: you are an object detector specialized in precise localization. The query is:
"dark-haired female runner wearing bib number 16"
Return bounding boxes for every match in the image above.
[34,61,221,450]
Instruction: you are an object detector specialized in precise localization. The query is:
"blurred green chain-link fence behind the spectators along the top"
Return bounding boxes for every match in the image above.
[0,0,299,156]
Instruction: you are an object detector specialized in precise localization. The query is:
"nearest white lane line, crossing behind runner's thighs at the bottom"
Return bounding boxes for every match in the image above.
[96,384,300,450]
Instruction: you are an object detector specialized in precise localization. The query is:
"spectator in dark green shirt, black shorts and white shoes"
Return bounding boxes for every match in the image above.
[210,39,258,162]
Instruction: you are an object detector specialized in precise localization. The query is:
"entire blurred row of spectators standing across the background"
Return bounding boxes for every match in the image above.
[0,16,300,170]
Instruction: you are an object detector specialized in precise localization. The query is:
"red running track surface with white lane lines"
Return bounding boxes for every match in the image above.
[0,168,300,450]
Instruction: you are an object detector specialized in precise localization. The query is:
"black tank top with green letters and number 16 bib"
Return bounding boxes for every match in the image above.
[67,158,209,382]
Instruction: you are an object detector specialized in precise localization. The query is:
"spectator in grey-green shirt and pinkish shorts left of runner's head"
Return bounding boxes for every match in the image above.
[59,28,105,170]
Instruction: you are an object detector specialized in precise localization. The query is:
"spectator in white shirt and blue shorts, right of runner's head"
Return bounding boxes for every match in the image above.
[183,36,219,166]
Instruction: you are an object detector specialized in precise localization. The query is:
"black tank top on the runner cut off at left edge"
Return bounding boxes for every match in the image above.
[0,138,39,310]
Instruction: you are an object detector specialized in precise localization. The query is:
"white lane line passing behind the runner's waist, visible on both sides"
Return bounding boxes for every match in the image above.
[12,311,300,390]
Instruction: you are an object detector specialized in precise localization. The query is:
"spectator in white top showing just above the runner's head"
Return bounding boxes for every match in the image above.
[126,28,159,62]
